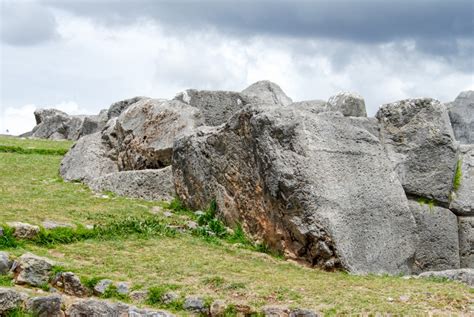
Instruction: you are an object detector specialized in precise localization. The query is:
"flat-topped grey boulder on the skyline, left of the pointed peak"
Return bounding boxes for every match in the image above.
[174,89,250,126]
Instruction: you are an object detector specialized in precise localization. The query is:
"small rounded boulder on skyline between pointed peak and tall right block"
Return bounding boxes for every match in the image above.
[327,92,367,117]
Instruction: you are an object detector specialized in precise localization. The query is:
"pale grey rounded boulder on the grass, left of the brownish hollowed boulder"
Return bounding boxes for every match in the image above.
[59,132,118,183]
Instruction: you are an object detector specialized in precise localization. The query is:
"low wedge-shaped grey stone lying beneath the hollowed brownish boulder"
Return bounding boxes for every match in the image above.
[89,166,175,200]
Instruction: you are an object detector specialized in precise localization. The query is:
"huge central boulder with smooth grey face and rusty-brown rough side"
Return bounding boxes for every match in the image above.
[173,105,416,273]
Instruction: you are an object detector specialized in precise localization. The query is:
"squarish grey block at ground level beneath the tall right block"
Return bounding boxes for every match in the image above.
[409,201,460,273]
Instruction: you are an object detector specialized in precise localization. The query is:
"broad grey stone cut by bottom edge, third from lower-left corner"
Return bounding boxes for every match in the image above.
[66,299,119,317]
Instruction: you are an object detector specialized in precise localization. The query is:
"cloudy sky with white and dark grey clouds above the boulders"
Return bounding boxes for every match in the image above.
[0,0,474,134]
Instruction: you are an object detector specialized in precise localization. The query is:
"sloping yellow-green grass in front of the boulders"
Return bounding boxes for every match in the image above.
[0,137,474,315]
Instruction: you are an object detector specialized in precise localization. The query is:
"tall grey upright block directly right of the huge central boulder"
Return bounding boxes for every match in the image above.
[376,98,457,205]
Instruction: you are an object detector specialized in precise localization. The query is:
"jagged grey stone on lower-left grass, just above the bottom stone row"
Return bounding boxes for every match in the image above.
[12,253,54,286]
